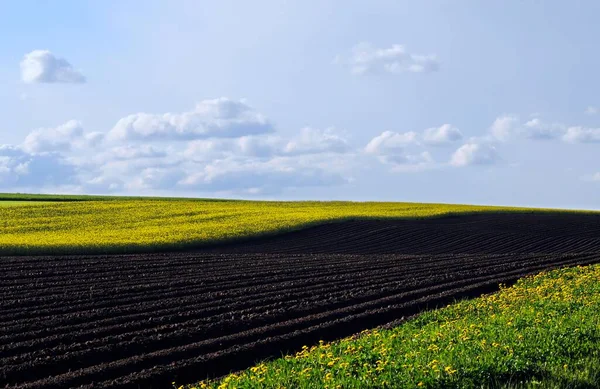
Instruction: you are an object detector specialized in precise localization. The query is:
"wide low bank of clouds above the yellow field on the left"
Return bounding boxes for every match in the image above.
[0,98,360,194]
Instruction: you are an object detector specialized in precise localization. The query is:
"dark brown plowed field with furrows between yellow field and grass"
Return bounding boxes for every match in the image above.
[0,214,600,388]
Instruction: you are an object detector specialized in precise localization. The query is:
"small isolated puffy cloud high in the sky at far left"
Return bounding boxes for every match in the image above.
[21,50,86,84]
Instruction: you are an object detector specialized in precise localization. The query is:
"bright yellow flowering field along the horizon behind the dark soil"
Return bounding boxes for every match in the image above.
[0,195,584,254]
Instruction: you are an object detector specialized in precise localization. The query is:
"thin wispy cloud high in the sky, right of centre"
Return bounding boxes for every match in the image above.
[335,42,439,74]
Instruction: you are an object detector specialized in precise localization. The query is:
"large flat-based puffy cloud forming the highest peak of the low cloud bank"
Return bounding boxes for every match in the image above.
[108,97,273,141]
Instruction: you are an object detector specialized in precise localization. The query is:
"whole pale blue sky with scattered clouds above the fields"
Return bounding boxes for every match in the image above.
[0,0,600,209]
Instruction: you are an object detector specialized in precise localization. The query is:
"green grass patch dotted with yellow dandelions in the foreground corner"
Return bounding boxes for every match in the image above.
[190,265,600,389]
